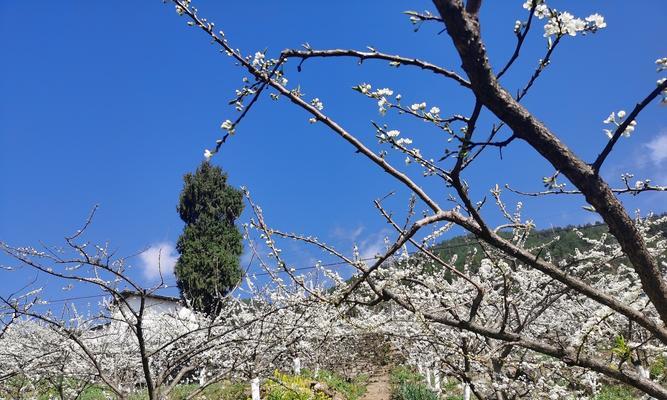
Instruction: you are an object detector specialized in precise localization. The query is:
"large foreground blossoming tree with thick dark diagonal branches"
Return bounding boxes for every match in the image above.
[163,0,667,398]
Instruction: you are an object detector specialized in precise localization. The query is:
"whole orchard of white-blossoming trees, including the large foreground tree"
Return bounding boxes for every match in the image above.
[0,0,667,400]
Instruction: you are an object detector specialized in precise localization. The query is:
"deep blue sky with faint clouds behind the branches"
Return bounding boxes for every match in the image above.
[0,0,667,304]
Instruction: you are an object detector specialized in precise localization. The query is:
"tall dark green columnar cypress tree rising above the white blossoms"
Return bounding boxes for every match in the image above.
[175,161,243,316]
